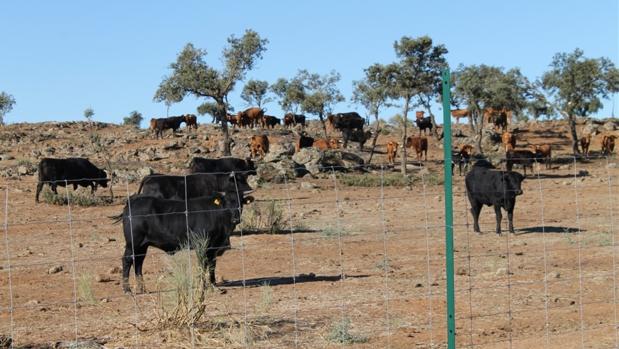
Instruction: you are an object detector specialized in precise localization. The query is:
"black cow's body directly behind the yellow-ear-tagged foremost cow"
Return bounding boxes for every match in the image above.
[138,172,253,200]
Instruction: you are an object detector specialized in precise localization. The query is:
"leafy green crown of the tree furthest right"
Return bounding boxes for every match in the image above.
[541,49,619,116]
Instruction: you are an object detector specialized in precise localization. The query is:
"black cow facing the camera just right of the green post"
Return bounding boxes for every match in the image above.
[464,160,524,235]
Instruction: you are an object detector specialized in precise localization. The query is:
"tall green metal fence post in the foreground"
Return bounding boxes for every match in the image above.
[443,68,456,349]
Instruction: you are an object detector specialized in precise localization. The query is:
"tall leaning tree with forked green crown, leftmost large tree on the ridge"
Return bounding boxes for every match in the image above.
[154,29,268,155]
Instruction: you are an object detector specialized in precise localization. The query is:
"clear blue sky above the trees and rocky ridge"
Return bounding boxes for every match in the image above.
[0,0,619,123]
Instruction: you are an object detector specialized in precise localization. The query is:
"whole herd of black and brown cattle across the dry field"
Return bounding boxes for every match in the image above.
[30,108,616,292]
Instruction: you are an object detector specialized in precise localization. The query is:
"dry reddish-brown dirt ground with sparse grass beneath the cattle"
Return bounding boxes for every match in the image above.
[0,118,619,349]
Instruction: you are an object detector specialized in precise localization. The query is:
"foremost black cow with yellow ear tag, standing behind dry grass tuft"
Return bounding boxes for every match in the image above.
[111,192,252,293]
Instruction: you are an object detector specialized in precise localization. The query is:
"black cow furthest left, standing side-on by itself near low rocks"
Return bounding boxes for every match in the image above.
[35,158,109,202]
